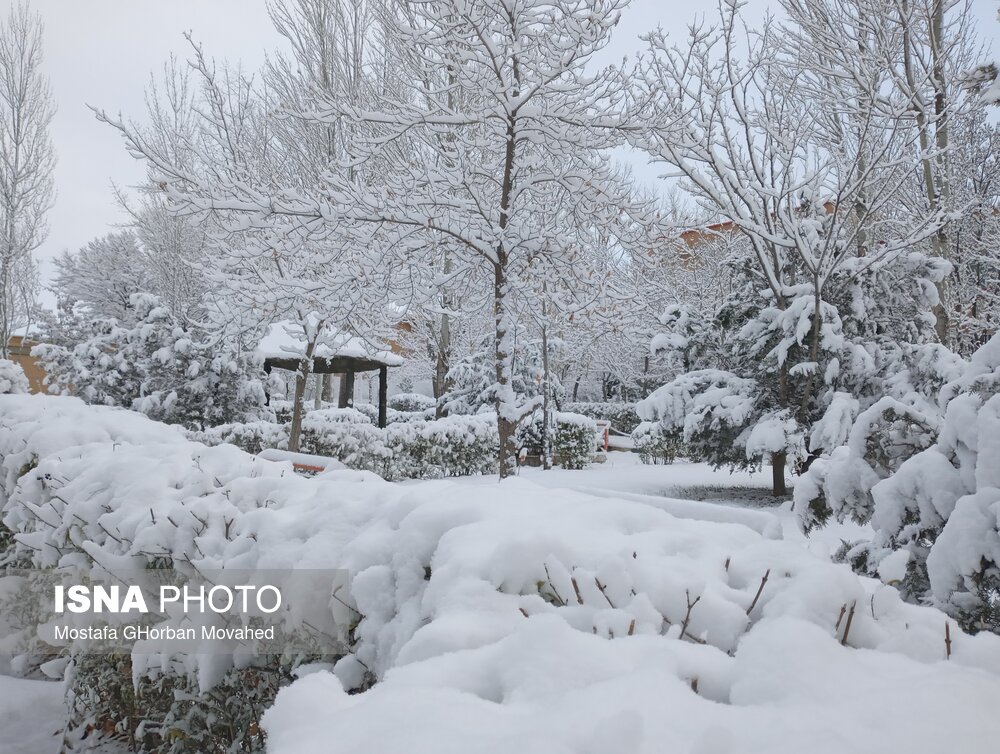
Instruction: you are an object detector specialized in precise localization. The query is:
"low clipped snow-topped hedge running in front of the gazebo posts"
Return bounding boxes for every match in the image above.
[191,409,498,480]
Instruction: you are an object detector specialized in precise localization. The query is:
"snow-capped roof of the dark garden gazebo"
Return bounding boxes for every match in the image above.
[257,321,403,374]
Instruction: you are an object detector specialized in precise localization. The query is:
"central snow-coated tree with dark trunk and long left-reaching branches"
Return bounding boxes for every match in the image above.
[103,0,648,476]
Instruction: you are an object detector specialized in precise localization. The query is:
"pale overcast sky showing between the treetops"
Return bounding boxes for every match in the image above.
[13,0,1000,298]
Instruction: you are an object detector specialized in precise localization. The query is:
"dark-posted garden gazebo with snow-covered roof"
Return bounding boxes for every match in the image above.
[257,322,403,427]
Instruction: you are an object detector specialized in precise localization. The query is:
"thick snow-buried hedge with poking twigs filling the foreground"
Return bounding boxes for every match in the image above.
[0,396,1000,754]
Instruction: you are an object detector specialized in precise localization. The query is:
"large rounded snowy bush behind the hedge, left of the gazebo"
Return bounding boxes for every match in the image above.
[33,294,264,429]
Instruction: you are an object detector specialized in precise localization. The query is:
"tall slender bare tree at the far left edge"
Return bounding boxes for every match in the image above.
[0,4,55,357]
